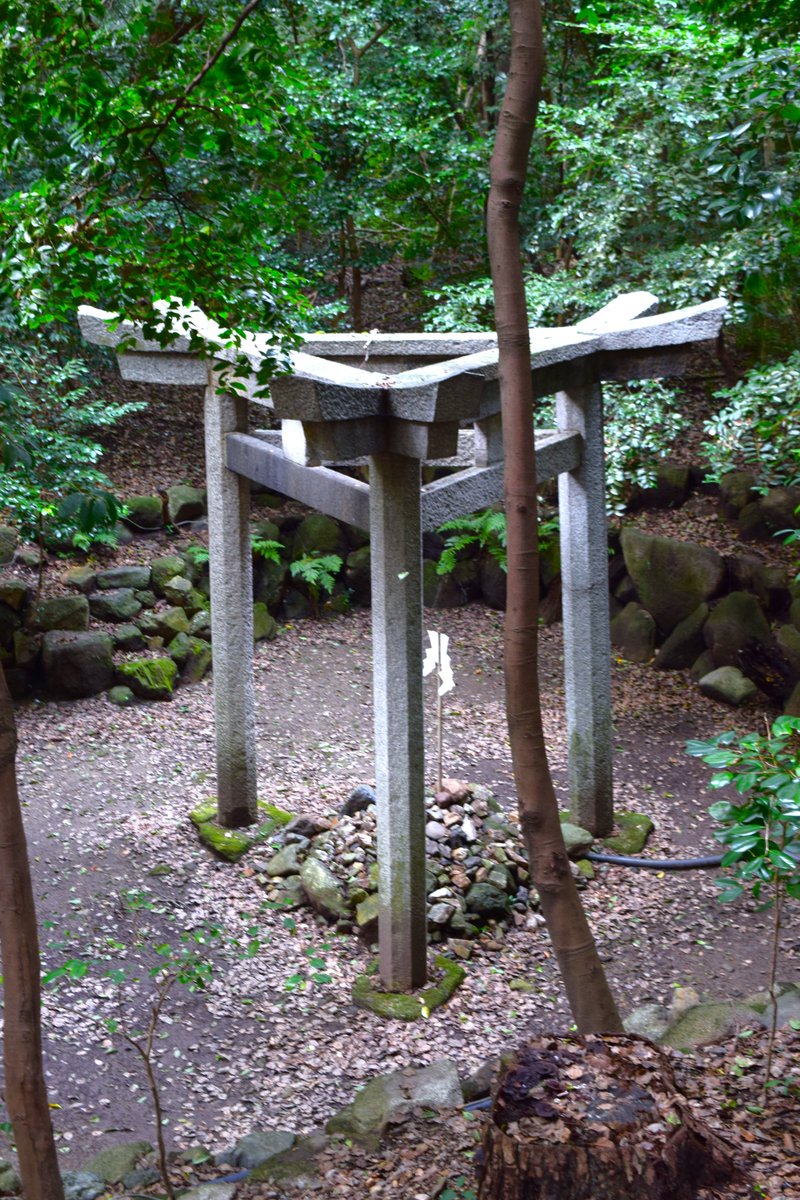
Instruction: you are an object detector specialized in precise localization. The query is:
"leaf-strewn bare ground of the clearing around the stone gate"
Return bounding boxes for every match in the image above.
[0,606,800,1166]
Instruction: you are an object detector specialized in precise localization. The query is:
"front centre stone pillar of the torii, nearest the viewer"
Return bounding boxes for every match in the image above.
[369,454,427,991]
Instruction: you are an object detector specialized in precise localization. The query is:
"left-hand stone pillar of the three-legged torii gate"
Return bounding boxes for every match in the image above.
[205,371,257,828]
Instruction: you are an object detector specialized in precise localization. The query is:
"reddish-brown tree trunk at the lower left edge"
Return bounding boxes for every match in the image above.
[0,670,64,1200]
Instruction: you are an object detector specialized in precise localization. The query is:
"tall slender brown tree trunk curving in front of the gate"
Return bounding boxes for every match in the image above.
[487,0,622,1033]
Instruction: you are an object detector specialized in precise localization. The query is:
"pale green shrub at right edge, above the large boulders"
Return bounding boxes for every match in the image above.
[703,350,800,491]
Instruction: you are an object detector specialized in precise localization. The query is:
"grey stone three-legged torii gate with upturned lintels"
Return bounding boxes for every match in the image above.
[79,293,726,990]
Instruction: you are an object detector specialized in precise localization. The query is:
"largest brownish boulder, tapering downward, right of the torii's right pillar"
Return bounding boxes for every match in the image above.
[620,526,724,634]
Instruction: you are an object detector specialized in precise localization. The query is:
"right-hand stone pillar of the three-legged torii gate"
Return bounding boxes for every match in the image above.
[555,383,614,836]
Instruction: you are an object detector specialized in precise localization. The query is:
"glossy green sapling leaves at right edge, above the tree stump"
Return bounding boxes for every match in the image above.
[686,716,800,906]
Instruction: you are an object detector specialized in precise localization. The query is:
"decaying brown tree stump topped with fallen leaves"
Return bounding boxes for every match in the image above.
[479,1036,739,1200]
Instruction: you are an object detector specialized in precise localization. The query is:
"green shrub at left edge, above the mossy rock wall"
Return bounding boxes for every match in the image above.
[0,341,146,548]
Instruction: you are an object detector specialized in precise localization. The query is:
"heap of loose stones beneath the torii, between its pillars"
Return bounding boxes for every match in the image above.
[247,779,591,956]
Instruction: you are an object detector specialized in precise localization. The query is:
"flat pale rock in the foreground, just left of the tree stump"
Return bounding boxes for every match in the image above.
[325,1058,463,1138]
